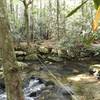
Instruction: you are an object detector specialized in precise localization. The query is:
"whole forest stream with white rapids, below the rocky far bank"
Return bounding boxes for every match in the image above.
[0,60,100,100]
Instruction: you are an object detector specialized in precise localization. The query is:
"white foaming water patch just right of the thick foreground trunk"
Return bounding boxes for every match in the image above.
[24,77,45,99]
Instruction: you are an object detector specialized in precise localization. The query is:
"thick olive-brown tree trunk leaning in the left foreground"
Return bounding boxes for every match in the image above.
[0,0,24,100]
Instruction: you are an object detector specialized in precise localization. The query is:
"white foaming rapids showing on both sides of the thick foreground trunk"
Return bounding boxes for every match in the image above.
[0,77,45,100]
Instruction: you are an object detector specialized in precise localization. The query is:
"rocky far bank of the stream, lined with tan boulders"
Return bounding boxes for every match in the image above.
[15,41,100,62]
